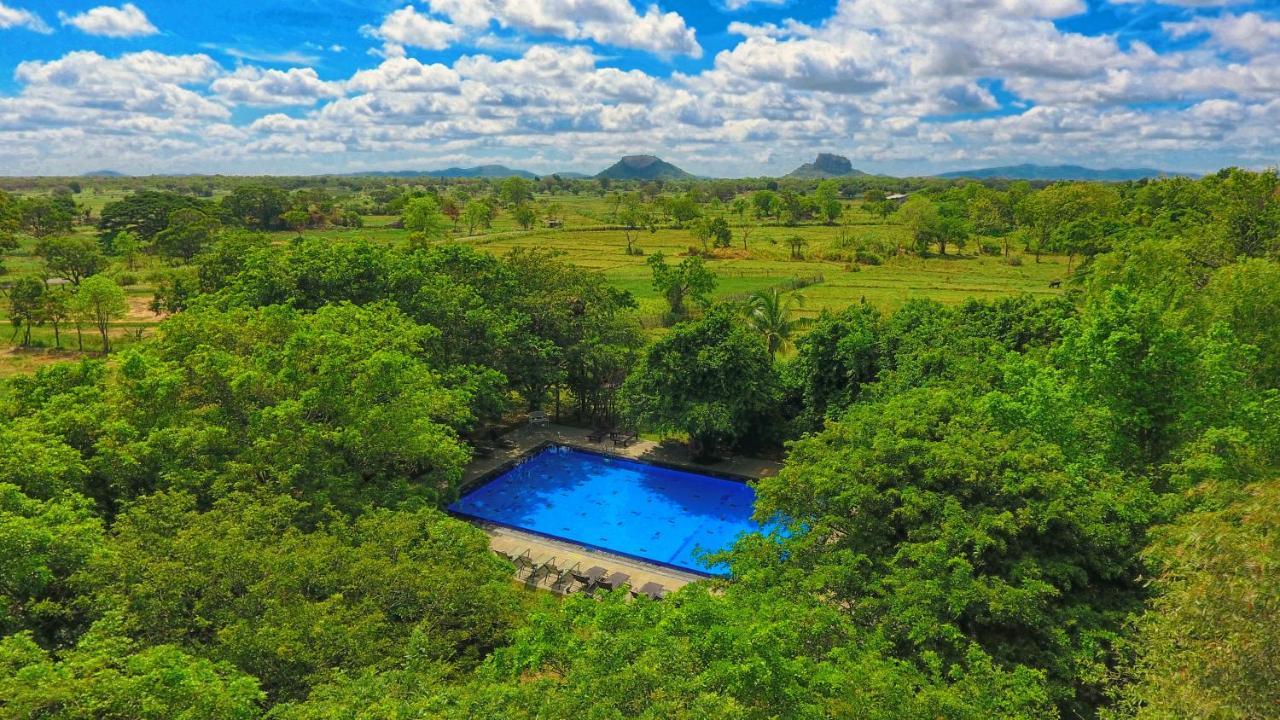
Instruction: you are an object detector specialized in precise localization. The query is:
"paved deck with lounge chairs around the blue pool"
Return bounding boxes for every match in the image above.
[462,423,781,591]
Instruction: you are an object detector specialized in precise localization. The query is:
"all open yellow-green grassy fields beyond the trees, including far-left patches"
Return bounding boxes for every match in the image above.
[0,188,1066,377]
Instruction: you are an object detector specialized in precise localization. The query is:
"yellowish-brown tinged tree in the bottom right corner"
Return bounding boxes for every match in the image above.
[1120,480,1280,720]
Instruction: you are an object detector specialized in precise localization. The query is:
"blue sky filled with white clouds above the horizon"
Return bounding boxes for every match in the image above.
[0,0,1280,177]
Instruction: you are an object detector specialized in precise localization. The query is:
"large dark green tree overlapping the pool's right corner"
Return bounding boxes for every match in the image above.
[735,387,1157,716]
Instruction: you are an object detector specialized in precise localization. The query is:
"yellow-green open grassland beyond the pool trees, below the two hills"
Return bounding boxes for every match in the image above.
[264,197,1066,315]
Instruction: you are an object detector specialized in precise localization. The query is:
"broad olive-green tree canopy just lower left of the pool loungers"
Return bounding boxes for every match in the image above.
[90,493,517,701]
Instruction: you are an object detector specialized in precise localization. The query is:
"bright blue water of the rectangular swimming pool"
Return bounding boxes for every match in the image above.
[449,447,760,574]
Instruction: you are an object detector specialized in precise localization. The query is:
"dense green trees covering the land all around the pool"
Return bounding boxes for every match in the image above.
[0,170,1280,720]
